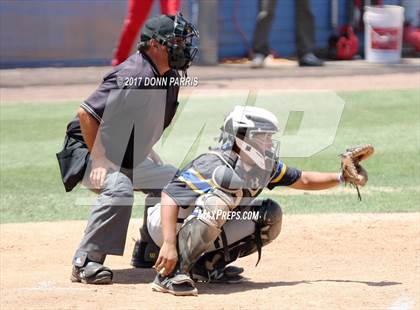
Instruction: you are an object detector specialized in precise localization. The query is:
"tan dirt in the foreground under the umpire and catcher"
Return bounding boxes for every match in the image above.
[0,213,420,309]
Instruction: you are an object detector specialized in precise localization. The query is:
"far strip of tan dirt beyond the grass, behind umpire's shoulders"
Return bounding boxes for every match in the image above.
[0,59,420,102]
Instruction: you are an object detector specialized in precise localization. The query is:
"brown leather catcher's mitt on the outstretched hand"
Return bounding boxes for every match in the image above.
[341,144,374,200]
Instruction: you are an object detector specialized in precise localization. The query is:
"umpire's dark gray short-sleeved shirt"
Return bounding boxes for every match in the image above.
[67,52,179,169]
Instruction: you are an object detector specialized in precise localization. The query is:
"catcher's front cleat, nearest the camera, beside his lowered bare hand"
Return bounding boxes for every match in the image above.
[152,274,198,296]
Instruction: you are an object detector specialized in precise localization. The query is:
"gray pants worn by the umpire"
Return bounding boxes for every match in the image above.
[73,159,176,266]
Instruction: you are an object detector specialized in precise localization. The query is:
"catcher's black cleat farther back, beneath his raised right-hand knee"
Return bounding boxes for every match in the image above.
[191,264,244,284]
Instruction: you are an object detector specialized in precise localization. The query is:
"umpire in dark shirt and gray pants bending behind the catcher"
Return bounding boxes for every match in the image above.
[57,14,198,284]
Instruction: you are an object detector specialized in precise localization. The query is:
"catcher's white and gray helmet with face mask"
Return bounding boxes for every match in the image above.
[220,106,279,170]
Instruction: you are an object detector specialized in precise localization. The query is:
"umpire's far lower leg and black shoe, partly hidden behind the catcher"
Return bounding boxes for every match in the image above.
[131,194,160,268]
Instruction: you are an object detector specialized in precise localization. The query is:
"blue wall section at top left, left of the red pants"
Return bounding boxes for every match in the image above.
[0,0,126,67]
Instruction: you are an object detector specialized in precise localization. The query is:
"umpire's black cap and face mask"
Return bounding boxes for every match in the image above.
[138,13,199,71]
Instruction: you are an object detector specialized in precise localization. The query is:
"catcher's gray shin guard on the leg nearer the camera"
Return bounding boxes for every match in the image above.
[176,191,232,274]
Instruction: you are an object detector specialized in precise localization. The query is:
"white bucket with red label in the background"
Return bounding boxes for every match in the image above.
[363,5,404,63]
